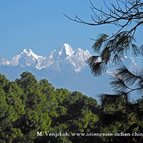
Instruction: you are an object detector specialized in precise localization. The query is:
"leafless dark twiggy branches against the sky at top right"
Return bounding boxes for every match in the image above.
[64,0,143,36]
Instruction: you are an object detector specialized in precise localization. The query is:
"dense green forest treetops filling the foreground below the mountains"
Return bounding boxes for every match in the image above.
[0,72,143,143]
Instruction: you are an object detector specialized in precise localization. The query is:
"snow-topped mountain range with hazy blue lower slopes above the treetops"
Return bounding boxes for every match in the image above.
[0,43,110,96]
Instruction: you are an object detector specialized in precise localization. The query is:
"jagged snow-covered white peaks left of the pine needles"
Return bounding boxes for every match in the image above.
[0,43,91,72]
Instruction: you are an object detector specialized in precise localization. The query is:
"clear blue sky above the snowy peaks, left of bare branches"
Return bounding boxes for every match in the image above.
[0,0,142,58]
